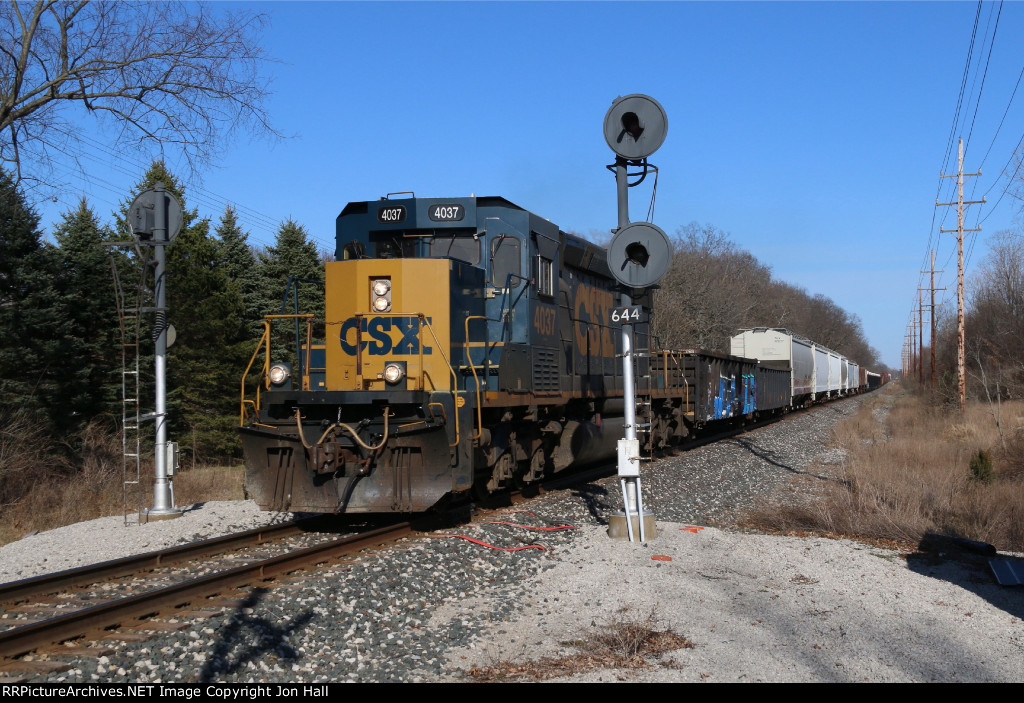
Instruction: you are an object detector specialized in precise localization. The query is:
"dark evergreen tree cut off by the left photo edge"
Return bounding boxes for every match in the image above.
[0,170,63,422]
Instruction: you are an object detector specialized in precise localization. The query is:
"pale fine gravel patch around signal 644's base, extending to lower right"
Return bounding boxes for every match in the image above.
[434,522,1024,683]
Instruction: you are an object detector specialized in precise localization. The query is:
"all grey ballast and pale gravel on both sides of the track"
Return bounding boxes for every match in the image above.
[0,396,1024,683]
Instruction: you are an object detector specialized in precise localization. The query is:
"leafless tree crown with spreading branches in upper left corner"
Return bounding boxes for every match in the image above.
[0,0,276,184]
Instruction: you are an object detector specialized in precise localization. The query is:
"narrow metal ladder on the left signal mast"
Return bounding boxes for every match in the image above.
[111,241,152,525]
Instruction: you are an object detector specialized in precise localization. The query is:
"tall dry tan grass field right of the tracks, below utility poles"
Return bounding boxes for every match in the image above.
[748,387,1024,552]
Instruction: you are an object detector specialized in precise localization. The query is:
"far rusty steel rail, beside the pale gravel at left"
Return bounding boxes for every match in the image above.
[0,518,331,603]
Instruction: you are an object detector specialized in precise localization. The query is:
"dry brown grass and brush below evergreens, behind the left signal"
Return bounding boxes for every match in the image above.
[0,418,244,544]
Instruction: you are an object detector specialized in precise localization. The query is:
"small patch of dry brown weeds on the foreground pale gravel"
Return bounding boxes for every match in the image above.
[466,608,693,682]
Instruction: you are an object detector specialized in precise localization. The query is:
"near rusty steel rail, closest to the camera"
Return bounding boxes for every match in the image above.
[0,523,413,659]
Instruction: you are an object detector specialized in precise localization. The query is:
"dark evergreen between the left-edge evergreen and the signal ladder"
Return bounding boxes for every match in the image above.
[53,197,121,433]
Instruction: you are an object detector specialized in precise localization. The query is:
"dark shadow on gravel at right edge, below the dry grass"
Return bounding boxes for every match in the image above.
[906,533,1024,620]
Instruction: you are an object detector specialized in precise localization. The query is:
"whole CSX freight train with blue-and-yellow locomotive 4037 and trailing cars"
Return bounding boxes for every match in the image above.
[240,197,879,513]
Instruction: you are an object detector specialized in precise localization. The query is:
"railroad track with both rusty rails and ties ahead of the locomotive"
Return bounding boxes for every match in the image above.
[0,522,414,677]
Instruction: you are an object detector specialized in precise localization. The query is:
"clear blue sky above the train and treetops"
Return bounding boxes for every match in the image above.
[29,1,1024,368]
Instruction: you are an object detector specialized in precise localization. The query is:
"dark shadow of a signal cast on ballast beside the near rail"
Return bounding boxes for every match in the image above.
[199,588,313,684]
